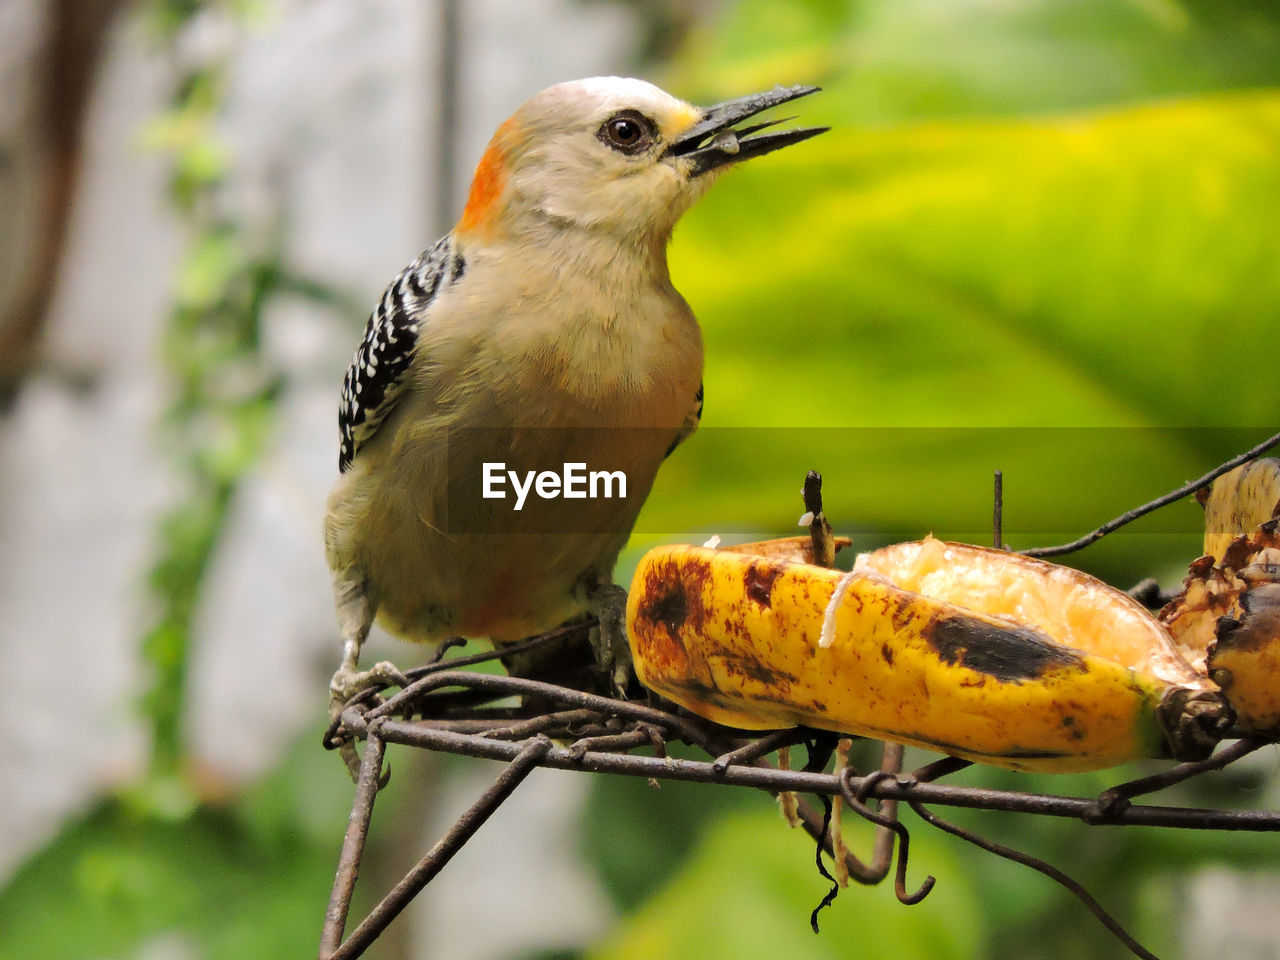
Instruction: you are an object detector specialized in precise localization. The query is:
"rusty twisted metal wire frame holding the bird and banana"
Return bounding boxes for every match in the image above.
[319,434,1280,960]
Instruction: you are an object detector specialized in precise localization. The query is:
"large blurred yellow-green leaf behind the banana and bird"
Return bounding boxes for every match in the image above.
[639,92,1280,579]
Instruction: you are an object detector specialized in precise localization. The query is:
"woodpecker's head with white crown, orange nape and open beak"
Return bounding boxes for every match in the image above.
[458,77,827,243]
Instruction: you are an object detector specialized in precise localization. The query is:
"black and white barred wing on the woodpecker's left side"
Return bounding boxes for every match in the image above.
[338,237,463,472]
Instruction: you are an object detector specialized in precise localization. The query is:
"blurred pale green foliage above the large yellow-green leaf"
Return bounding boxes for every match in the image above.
[668,0,1280,127]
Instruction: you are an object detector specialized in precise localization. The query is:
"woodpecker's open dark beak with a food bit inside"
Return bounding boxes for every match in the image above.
[666,87,831,177]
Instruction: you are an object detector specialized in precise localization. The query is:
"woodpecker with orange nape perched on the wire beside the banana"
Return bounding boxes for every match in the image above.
[325,77,826,727]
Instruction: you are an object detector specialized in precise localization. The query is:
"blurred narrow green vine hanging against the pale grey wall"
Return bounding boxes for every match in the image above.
[138,7,348,788]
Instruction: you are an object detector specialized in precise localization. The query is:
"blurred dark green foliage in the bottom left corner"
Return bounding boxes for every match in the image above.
[0,739,353,960]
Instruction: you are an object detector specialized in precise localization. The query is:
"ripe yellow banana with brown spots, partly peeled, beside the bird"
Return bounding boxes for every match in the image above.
[627,539,1229,772]
